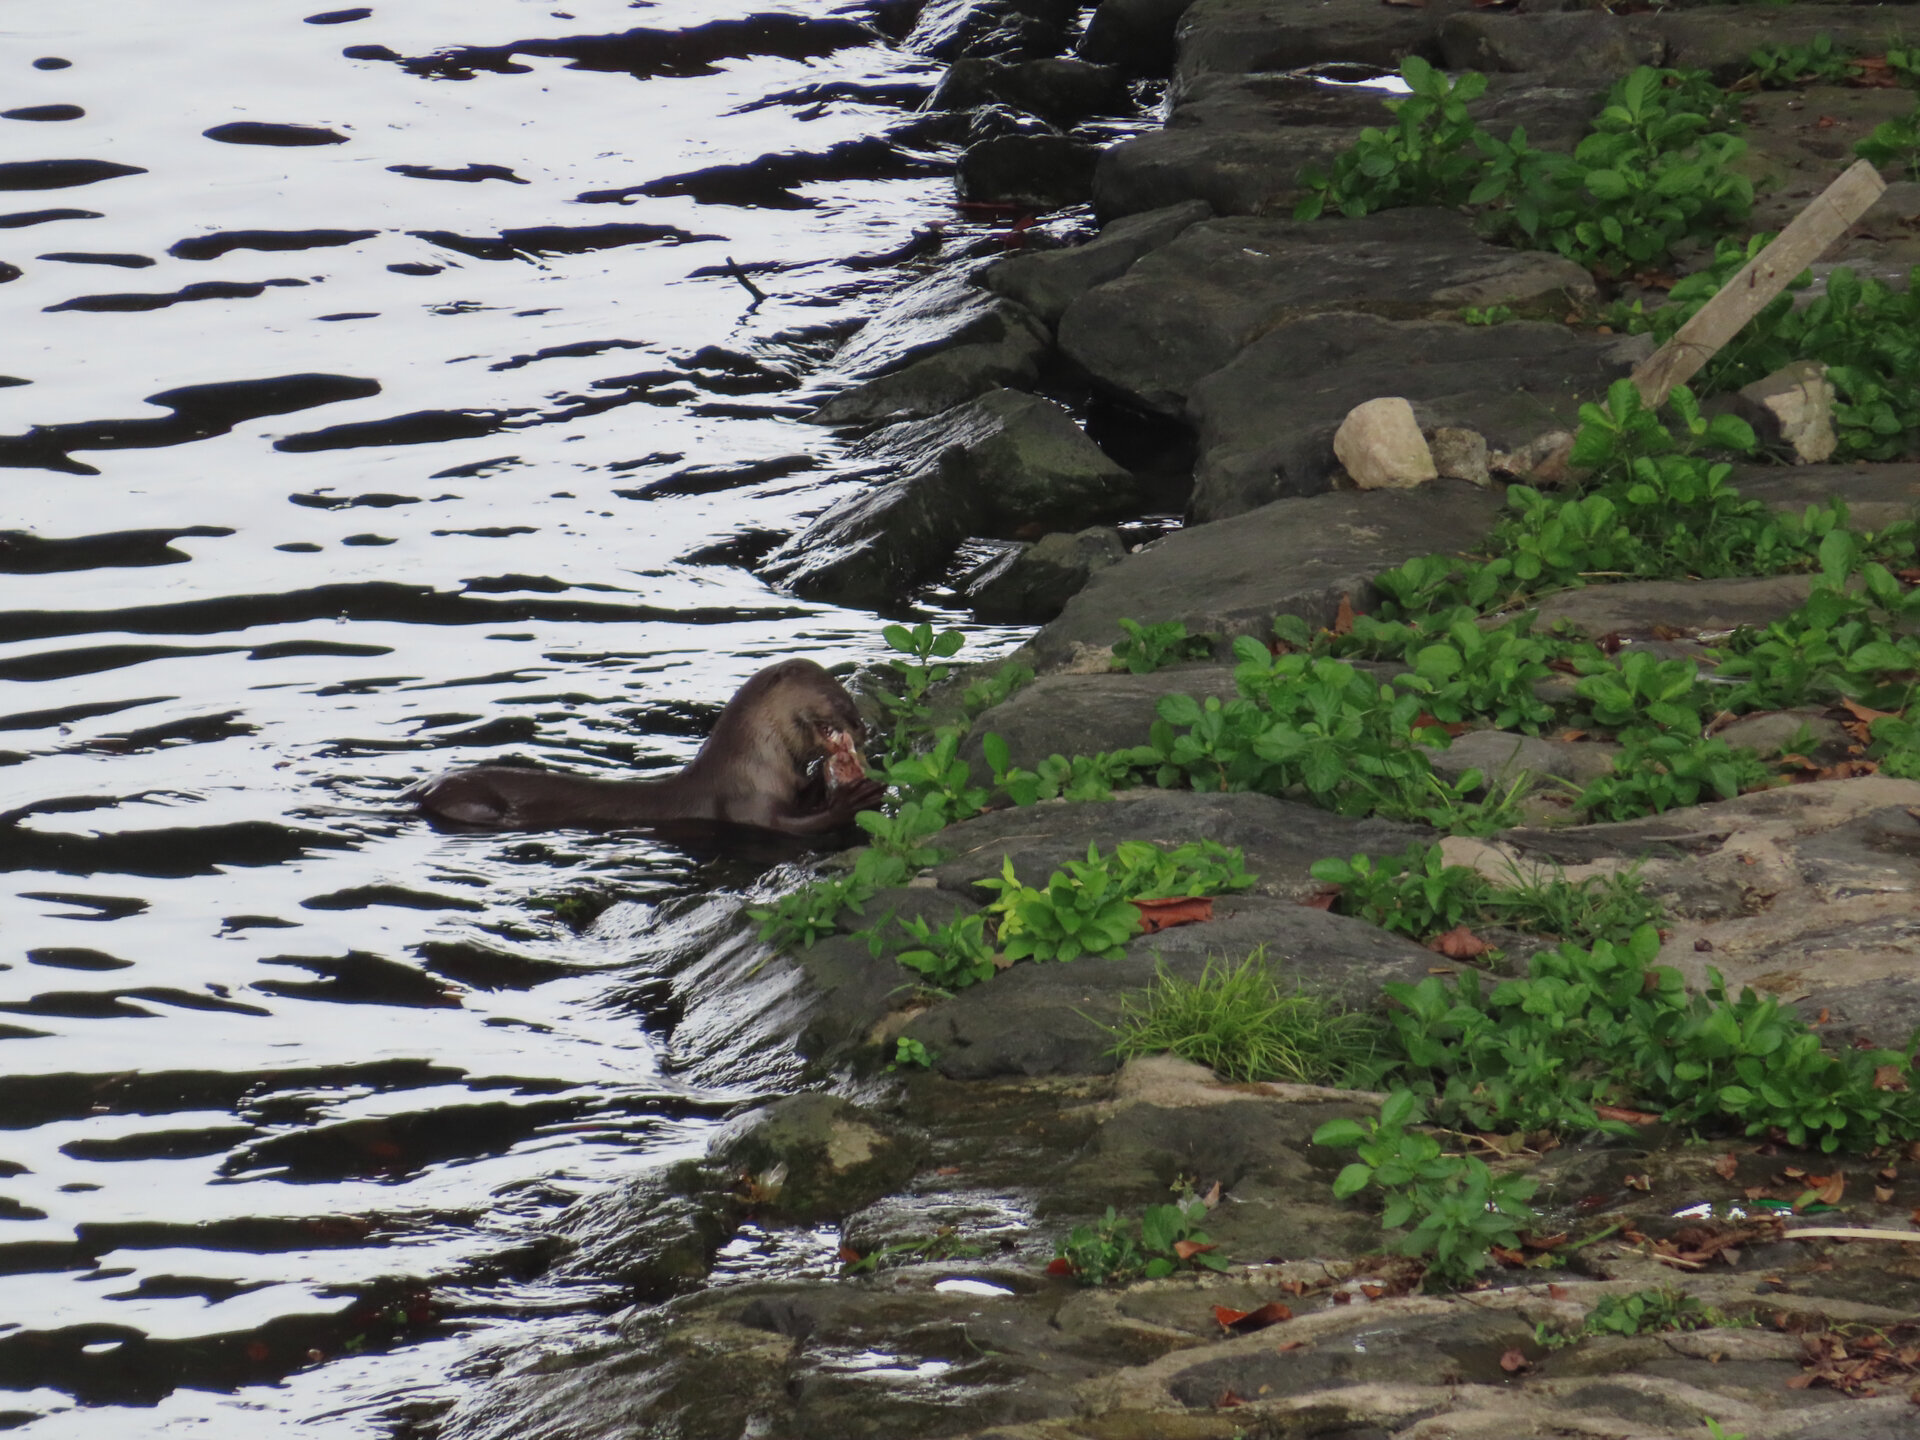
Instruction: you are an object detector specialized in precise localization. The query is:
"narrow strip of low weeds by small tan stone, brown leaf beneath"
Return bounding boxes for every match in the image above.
[1313,845,1663,945]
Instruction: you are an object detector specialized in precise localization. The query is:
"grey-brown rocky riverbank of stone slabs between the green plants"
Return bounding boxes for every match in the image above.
[438,0,1920,1440]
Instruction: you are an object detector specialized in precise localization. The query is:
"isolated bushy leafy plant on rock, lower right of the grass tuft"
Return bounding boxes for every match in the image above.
[1313,1089,1538,1288]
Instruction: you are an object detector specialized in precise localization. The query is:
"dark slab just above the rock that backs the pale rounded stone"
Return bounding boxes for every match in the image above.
[1060,209,1594,417]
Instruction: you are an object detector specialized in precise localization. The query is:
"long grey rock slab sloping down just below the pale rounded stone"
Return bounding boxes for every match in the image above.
[1033,480,1503,670]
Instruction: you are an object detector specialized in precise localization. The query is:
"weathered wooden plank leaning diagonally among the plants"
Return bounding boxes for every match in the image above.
[1634,159,1887,409]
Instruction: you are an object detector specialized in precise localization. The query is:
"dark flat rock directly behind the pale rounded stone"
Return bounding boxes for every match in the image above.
[1187,313,1649,520]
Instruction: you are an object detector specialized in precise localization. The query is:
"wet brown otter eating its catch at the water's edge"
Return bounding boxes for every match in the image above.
[411,660,885,835]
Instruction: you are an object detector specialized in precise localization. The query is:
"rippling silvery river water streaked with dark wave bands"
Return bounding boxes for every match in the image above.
[0,0,1090,1440]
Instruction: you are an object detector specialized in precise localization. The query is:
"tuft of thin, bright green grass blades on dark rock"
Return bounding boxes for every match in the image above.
[1110,960,1379,1085]
